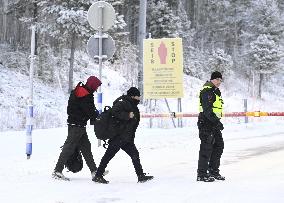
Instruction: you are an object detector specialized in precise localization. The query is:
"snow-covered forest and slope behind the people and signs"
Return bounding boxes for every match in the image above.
[0,0,284,130]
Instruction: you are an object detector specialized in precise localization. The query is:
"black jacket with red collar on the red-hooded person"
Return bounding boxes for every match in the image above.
[67,83,99,126]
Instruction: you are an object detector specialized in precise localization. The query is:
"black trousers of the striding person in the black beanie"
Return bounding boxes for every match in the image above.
[96,137,143,176]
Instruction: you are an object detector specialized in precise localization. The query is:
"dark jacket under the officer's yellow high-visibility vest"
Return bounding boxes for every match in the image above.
[198,81,223,128]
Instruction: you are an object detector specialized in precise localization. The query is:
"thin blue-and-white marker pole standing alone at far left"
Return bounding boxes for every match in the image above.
[26,26,35,159]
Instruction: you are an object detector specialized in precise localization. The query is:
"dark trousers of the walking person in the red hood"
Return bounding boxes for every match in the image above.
[54,126,97,172]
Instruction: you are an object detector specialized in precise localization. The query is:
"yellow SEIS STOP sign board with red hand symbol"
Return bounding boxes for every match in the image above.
[143,38,183,99]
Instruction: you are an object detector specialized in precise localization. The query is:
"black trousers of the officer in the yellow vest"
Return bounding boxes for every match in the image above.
[198,129,224,174]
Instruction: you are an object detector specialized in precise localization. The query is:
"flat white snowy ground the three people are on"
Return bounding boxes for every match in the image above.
[0,121,284,203]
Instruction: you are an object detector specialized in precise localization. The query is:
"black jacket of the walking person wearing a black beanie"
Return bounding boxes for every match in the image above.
[112,95,140,142]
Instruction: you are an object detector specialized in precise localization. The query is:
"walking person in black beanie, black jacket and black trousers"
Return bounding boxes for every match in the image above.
[93,87,153,184]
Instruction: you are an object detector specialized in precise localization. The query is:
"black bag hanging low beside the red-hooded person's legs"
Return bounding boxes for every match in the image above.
[65,148,83,173]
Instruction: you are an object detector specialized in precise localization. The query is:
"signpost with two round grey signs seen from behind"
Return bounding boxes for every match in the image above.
[87,1,115,146]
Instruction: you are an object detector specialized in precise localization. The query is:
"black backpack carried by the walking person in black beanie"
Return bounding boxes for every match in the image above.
[94,106,119,147]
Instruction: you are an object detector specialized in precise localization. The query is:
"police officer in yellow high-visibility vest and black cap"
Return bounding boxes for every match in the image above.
[197,71,225,182]
